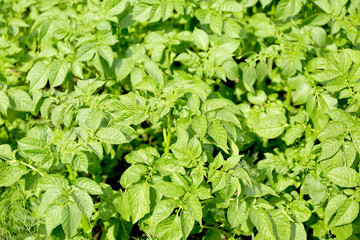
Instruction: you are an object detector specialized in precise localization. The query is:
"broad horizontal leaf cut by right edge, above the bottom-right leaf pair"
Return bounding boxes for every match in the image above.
[327,167,360,188]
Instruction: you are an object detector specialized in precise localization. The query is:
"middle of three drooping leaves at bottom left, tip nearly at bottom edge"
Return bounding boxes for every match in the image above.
[61,202,82,238]
